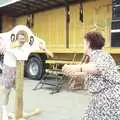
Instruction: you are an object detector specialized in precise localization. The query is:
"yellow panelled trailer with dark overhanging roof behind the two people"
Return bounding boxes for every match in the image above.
[0,0,120,79]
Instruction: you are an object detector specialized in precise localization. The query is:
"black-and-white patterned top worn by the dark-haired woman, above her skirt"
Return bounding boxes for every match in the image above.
[88,50,120,93]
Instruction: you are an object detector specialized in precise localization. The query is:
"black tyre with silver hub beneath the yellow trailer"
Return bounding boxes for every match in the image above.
[25,56,45,80]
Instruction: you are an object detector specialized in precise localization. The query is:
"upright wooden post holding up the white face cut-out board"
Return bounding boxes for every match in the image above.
[15,60,24,120]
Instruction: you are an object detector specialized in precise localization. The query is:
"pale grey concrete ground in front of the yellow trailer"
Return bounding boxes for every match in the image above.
[2,79,90,120]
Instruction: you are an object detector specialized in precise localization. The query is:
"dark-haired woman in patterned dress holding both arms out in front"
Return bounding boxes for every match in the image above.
[62,32,120,120]
